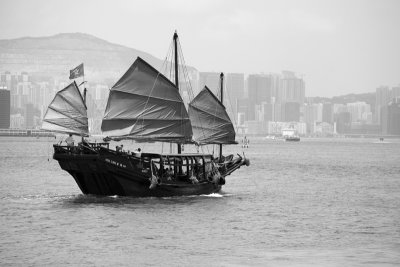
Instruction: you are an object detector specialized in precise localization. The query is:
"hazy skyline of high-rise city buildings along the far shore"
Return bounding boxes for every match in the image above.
[0,68,400,137]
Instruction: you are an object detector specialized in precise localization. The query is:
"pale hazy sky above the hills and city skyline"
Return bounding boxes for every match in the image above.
[0,0,400,96]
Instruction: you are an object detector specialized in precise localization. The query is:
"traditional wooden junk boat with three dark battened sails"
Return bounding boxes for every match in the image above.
[42,32,250,197]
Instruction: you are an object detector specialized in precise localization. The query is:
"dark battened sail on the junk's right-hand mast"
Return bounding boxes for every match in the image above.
[189,86,236,145]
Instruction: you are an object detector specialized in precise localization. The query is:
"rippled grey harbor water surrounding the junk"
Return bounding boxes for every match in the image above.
[0,137,400,266]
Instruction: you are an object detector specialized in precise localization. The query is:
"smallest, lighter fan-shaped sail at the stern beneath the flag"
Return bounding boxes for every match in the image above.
[41,82,89,136]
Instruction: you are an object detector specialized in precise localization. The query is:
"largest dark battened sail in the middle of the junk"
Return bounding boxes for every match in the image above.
[101,57,192,143]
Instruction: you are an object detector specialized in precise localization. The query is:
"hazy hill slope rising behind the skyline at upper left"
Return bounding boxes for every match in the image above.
[0,33,168,81]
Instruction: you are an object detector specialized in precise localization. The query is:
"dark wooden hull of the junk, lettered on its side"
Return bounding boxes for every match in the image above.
[54,153,227,197]
